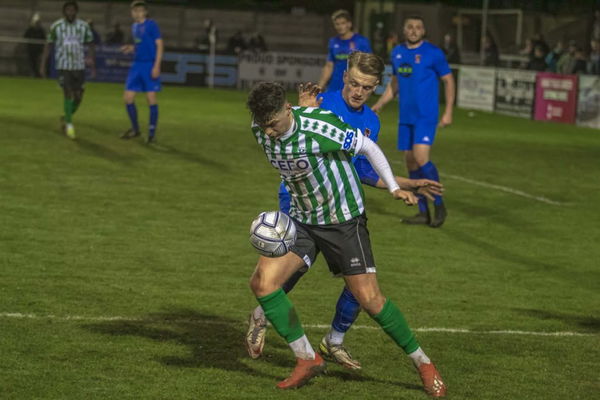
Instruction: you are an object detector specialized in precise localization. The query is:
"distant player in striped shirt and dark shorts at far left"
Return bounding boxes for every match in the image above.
[40,1,95,139]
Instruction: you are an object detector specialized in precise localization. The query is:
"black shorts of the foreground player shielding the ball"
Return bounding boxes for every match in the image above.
[291,214,376,276]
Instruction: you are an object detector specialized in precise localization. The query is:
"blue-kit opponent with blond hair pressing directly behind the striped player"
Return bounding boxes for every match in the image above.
[246,51,442,369]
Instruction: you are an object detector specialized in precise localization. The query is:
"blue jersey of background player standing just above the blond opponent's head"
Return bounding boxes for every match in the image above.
[327,33,373,91]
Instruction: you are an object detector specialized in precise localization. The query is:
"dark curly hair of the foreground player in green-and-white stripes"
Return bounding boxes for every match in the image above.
[246,82,287,125]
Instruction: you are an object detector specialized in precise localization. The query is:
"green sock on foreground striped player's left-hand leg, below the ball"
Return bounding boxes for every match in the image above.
[256,289,304,343]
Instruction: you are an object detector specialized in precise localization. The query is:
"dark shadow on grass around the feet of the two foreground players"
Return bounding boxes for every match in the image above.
[82,309,422,391]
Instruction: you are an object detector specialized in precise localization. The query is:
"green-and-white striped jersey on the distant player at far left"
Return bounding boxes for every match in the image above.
[48,18,94,71]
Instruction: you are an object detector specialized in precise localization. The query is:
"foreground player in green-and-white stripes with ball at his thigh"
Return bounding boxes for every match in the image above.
[247,82,445,397]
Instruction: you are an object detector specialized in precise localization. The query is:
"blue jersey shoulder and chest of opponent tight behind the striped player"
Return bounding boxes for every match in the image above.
[318,90,381,159]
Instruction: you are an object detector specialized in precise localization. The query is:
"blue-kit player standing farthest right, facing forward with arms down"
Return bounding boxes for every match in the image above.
[373,16,455,228]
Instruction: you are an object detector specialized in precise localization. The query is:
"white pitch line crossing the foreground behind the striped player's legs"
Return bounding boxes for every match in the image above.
[0,312,600,337]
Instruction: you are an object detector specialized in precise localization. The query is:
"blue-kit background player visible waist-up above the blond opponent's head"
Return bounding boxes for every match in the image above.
[319,10,372,91]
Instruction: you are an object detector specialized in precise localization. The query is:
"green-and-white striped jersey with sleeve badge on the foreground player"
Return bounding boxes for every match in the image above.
[252,107,364,225]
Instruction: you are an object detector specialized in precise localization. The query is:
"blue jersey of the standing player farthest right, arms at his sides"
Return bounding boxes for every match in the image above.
[391,42,451,124]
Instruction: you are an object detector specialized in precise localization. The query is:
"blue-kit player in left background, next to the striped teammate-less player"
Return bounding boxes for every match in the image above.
[121,1,164,143]
